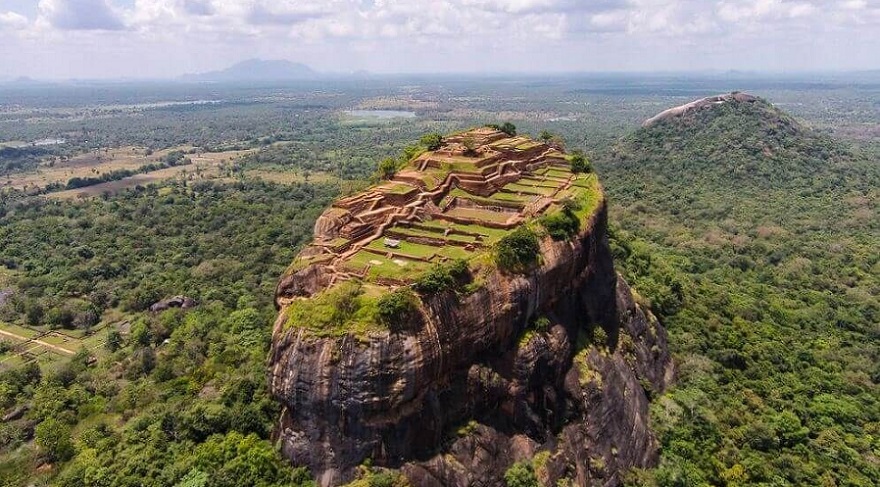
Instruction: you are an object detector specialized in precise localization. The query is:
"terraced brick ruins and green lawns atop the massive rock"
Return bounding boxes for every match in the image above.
[291,128,588,294]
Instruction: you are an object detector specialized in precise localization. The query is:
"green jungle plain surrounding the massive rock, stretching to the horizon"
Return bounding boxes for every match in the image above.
[0,75,880,487]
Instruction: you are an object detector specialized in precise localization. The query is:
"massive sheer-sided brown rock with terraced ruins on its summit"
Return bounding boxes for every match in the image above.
[269,130,672,486]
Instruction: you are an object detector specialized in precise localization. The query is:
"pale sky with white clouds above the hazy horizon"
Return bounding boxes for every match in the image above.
[0,0,880,79]
